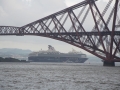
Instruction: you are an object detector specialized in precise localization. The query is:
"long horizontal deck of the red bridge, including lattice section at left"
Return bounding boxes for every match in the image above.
[0,26,120,36]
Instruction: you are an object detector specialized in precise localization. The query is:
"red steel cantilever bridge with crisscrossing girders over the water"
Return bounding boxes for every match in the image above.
[0,0,120,66]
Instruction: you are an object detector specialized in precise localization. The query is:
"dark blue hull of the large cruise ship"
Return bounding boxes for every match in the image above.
[28,56,88,63]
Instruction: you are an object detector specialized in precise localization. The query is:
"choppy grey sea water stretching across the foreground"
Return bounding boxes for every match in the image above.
[0,56,120,90]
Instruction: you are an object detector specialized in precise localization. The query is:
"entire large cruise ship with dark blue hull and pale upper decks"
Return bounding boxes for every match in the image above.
[28,45,88,63]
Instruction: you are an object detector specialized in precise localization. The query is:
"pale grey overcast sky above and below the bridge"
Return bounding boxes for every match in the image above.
[0,0,110,52]
